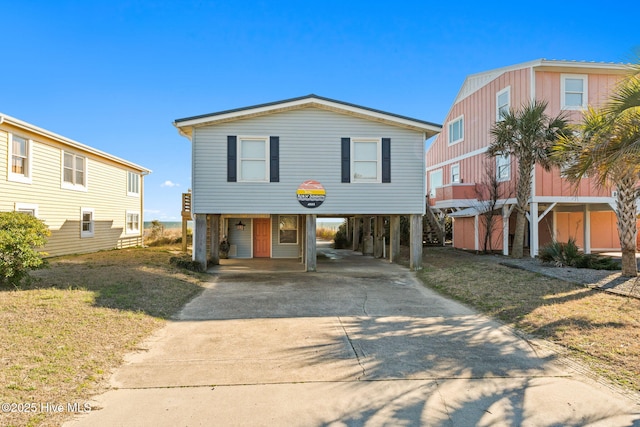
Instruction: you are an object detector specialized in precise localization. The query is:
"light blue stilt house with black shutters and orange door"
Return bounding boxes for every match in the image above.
[174,95,441,271]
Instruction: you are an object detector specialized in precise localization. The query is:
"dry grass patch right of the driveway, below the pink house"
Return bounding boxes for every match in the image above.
[419,248,640,392]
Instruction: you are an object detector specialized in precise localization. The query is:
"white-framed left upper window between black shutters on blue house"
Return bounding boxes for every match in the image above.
[238,136,269,182]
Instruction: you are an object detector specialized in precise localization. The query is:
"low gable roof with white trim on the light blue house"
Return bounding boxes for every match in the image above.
[173,94,442,138]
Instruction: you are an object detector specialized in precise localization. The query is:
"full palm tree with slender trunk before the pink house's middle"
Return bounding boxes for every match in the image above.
[487,100,568,258]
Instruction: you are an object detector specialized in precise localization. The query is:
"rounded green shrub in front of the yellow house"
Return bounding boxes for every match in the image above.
[0,212,50,286]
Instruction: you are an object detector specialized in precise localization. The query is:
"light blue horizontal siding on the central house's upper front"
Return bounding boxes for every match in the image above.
[192,108,425,214]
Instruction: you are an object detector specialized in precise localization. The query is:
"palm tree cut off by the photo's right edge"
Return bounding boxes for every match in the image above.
[553,65,640,277]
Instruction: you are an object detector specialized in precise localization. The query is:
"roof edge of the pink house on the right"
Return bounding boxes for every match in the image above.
[453,58,629,104]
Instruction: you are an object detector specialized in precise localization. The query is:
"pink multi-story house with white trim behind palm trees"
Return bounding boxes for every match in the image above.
[426,59,627,256]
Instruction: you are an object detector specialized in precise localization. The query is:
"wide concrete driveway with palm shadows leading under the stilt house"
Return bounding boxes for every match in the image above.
[67,248,640,426]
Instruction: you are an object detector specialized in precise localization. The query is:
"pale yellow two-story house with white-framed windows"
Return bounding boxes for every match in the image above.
[0,113,151,256]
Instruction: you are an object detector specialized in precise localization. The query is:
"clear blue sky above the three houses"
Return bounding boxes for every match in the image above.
[0,0,640,221]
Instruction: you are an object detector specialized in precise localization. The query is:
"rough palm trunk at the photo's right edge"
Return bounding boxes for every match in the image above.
[616,177,638,277]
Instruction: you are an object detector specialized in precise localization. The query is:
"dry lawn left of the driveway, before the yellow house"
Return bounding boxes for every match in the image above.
[0,249,202,426]
